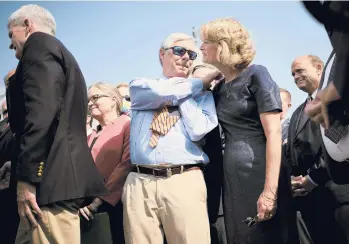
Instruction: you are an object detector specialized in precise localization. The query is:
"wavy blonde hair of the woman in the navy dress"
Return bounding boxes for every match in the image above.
[201,18,256,70]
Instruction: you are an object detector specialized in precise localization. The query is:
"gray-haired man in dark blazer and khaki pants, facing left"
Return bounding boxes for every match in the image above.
[8,5,106,244]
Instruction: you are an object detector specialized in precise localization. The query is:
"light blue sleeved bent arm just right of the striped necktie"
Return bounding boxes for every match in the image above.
[179,92,218,141]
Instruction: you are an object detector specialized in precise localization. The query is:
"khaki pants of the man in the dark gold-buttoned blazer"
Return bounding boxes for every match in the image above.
[15,201,80,244]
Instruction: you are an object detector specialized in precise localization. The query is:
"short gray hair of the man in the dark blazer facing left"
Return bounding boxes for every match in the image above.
[7,4,56,36]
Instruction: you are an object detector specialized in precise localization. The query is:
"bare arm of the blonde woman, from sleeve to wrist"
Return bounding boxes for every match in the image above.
[260,112,281,192]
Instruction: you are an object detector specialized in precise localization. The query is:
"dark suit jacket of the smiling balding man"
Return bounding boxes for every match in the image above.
[285,102,329,184]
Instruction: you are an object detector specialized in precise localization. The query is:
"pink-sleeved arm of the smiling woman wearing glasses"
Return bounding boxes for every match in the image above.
[100,120,132,206]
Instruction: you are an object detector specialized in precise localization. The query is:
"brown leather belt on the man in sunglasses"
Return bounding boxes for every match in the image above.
[132,164,202,178]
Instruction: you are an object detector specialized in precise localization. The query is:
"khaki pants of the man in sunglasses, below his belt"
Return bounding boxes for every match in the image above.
[122,170,211,244]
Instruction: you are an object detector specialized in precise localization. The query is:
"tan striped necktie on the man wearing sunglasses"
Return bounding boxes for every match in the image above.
[149,106,180,148]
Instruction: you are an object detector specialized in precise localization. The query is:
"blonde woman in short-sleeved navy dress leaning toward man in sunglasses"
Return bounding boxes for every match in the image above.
[201,18,298,244]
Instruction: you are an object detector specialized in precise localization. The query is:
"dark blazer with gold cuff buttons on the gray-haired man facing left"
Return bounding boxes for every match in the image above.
[8,32,107,205]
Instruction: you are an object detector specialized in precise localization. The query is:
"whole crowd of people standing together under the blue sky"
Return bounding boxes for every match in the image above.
[0,1,349,244]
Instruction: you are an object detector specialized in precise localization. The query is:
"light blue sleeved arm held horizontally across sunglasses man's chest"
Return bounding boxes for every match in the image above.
[130,78,203,110]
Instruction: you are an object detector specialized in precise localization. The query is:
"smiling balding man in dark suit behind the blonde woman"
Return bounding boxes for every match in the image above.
[286,55,346,244]
